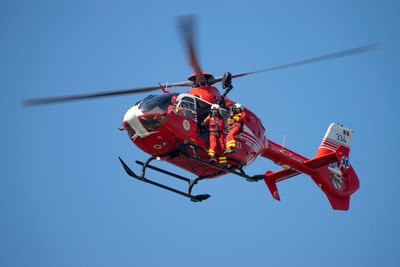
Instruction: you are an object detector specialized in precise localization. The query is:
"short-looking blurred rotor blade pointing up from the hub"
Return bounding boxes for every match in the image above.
[178,15,205,83]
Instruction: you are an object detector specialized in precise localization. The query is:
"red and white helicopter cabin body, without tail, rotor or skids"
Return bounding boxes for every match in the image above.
[123,86,267,177]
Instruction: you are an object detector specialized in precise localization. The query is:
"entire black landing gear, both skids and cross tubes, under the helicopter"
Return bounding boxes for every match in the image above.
[119,142,265,202]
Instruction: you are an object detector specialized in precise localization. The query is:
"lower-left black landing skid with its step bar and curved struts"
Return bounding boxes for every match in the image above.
[118,156,210,202]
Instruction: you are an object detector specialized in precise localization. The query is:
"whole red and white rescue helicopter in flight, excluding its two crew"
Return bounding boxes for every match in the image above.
[23,15,377,210]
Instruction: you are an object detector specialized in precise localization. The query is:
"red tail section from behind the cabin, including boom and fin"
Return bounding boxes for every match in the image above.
[262,124,359,210]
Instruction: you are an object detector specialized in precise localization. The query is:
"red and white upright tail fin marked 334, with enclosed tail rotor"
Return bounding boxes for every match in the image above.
[306,123,359,210]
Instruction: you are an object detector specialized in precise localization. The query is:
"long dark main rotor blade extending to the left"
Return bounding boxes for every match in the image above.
[23,81,192,106]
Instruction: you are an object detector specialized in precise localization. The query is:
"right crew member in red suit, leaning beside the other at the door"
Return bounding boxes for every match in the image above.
[224,103,246,154]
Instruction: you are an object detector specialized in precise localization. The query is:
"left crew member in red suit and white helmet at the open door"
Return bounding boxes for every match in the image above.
[201,104,226,165]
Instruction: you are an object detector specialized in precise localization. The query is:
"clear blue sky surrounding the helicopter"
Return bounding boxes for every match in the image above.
[0,0,400,267]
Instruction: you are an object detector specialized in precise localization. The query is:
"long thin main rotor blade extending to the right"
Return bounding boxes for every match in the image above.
[214,44,379,83]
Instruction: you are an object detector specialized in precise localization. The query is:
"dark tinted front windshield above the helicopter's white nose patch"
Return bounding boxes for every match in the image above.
[138,93,179,114]
